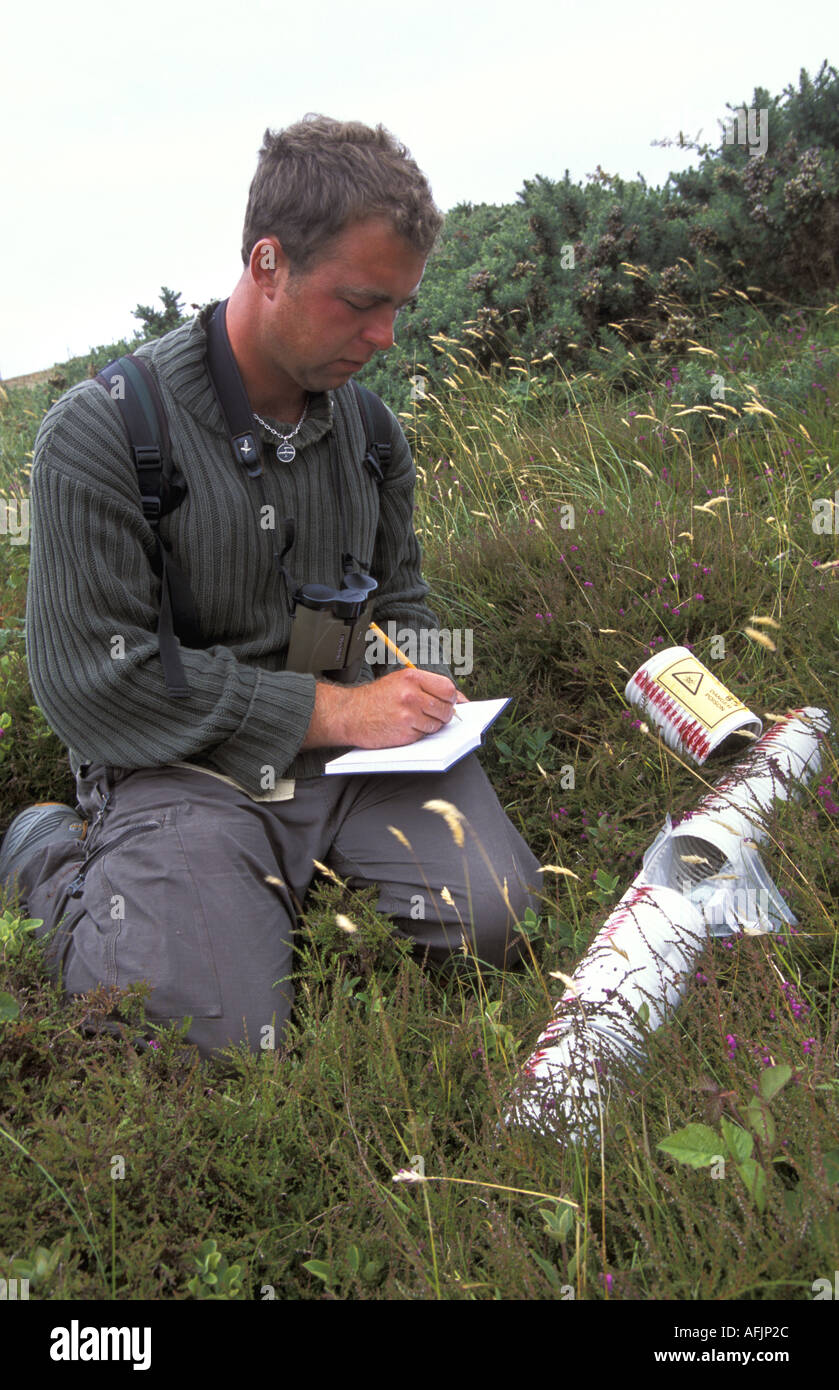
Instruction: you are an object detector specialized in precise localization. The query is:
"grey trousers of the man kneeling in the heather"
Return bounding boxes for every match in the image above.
[18,755,542,1056]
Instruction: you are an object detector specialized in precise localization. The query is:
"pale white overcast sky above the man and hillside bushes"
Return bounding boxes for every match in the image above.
[0,0,839,378]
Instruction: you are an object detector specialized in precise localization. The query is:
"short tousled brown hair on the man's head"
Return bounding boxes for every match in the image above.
[242,113,443,274]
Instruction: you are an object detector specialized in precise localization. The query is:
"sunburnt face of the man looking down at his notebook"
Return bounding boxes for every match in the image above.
[263,218,425,391]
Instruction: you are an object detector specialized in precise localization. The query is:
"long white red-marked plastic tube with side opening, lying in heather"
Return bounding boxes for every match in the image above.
[507,708,829,1141]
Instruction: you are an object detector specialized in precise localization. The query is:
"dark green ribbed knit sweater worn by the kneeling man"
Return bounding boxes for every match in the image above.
[26,304,450,799]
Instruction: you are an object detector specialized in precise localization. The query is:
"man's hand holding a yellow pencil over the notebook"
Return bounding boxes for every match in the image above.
[300,669,467,751]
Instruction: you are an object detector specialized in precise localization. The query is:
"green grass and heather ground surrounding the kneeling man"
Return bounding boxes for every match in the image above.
[0,293,839,1301]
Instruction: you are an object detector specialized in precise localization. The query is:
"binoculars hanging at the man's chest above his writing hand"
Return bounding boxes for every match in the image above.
[285,570,378,685]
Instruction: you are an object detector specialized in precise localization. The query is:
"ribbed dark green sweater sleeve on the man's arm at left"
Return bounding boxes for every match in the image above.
[26,388,315,794]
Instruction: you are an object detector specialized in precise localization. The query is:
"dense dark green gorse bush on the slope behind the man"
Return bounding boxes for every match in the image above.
[354,63,839,409]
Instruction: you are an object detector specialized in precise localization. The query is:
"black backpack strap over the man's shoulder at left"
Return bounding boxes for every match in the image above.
[96,354,204,698]
